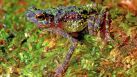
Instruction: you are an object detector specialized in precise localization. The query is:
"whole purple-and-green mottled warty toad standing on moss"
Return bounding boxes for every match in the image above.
[26,4,110,77]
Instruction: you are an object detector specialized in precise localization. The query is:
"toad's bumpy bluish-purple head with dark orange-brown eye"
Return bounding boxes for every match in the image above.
[26,7,53,27]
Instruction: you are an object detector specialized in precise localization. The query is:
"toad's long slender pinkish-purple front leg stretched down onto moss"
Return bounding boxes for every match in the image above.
[42,28,77,77]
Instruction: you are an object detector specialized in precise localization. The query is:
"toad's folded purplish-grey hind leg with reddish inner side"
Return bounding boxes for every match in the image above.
[88,10,111,41]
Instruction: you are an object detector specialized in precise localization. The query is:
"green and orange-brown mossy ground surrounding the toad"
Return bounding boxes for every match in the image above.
[0,0,137,77]
